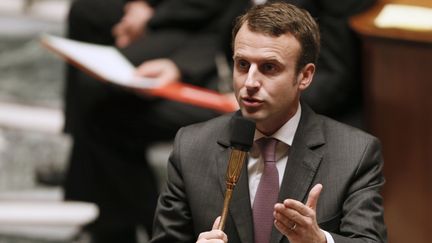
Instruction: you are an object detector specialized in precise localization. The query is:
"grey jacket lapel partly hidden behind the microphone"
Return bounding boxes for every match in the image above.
[216,114,253,243]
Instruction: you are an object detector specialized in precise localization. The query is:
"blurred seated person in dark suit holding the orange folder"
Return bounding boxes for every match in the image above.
[64,0,248,243]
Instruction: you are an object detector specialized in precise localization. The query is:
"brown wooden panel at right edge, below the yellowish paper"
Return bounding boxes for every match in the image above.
[364,38,432,243]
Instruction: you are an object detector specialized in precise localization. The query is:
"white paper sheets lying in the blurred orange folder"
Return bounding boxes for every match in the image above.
[42,35,157,89]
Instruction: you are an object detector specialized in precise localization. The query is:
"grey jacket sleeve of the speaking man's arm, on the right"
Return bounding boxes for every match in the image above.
[332,139,387,243]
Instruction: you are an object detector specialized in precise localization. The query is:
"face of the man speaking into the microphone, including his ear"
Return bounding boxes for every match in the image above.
[233,24,315,135]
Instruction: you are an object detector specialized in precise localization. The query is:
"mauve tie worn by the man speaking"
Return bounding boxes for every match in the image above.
[252,138,279,243]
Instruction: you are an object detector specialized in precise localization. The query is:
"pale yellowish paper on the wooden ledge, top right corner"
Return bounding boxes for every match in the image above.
[374,4,432,31]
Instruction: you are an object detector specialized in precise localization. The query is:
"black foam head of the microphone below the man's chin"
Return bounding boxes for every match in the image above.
[230,116,255,151]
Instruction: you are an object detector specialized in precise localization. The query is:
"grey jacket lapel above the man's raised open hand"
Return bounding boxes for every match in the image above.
[270,105,325,243]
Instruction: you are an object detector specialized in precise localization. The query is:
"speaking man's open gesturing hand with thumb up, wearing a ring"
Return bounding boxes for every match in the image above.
[274,184,326,243]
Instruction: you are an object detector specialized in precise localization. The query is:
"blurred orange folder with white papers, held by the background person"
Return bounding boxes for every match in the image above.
[41,35,237,113]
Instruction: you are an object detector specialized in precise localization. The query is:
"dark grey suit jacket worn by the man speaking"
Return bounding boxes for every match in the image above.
[151,103,387,243]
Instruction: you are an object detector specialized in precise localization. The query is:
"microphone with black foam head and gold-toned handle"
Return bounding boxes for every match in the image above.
[218,116,255,230]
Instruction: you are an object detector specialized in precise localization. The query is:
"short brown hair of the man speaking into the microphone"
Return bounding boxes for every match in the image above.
[232,2,320,72]
